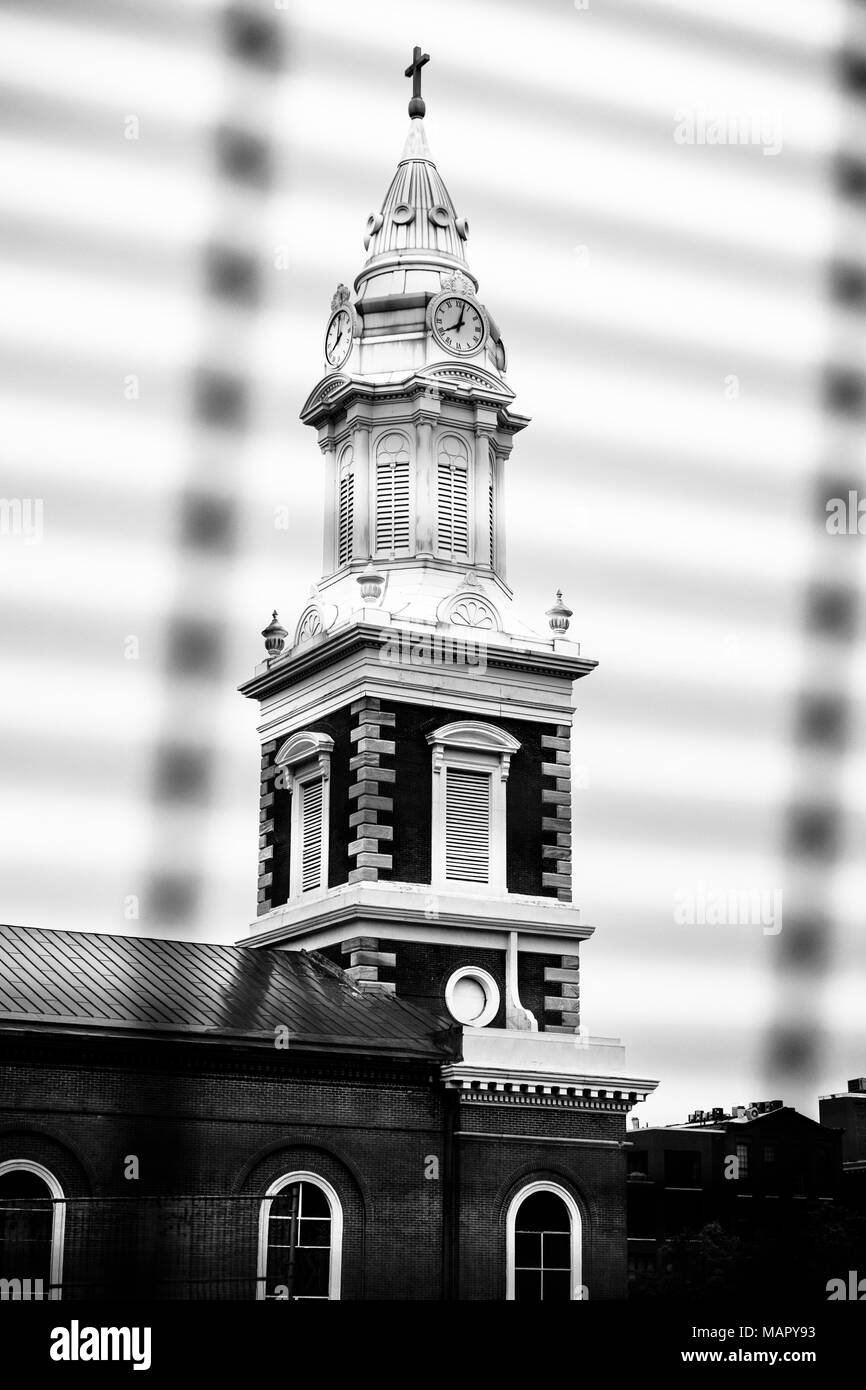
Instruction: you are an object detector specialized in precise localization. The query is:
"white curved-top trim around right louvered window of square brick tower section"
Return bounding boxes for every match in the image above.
[427,720,520,895]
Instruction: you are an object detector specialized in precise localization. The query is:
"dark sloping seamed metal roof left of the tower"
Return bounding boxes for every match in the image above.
[0,926,452,1056]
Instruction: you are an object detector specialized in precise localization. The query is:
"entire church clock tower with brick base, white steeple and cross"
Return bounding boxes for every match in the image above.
[240,49,656,1277]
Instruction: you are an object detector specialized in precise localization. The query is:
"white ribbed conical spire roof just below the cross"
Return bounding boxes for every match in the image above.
[367,120,466,265]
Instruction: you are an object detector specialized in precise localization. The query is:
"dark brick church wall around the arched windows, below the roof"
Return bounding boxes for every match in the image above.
[0,1037,626,1300]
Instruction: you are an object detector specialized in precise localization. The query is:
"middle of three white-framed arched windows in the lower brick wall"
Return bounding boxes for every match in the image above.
[256,1173,343,1300]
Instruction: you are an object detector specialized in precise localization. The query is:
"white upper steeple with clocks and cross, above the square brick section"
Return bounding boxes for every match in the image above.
[299,49,532,638]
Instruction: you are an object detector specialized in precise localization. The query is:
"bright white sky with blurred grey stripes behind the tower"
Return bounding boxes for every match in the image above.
[0,0,866,1122]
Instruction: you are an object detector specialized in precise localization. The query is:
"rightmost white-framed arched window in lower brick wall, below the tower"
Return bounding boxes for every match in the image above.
[506,1183,584,1302]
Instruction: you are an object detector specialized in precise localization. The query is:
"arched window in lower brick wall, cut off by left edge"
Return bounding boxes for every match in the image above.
[0,1158,65,1300]
